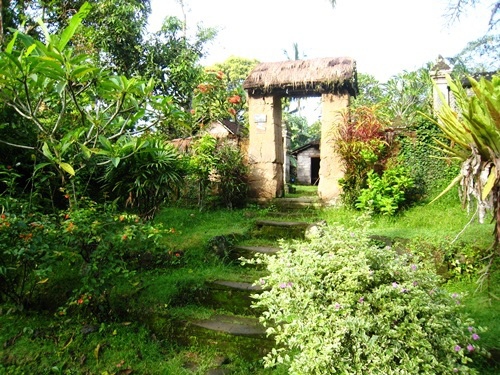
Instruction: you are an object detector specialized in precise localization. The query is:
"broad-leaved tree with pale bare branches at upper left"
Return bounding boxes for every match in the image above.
[0,3,161,209]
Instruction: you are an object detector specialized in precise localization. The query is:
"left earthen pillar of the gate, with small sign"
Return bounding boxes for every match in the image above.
[248,96,284,201]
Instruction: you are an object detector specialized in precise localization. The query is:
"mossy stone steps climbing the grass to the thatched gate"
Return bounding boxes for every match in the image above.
[170,198,320,375]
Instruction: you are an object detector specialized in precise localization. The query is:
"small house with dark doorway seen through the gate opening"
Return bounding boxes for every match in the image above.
[291,140,320,185]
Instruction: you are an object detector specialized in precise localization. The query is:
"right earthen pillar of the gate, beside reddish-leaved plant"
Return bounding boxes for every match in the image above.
[318,93,349,205]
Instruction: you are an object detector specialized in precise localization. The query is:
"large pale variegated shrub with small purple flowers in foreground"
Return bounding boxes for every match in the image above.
[250,219,482,375]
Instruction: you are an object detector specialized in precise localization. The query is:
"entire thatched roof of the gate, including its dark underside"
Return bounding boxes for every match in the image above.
[243,57,358,96]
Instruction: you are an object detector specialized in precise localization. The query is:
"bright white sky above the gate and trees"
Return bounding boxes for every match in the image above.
[149,0,490,82]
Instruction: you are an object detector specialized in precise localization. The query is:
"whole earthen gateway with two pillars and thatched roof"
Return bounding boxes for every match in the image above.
[243,57,358,204]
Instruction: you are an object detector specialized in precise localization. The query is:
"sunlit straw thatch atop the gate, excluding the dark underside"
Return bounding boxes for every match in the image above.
[243,57,356,91]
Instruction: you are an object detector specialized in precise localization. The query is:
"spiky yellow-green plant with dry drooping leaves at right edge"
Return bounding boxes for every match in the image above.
[435,73,500,249]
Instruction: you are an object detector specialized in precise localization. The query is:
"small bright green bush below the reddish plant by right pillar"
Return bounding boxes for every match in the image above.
[356,166,414,216]
